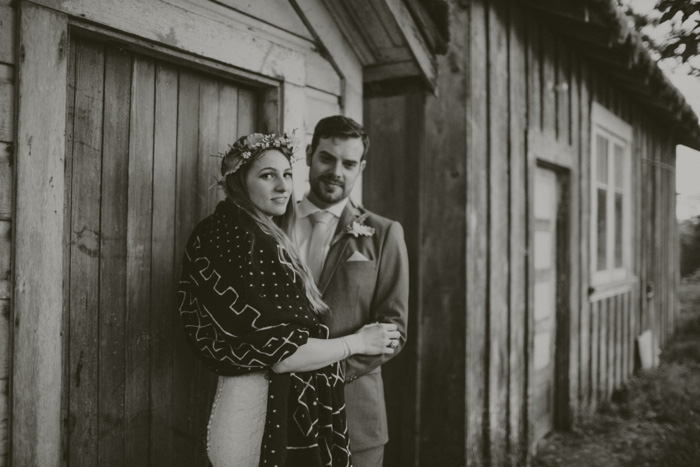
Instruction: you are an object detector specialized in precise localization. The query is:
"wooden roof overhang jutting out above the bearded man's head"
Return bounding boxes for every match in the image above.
[323,0,441,90]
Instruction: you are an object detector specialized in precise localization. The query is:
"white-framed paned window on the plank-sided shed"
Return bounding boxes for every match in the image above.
[591,102,632,285]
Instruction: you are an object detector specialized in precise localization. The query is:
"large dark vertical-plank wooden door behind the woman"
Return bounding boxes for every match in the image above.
[63,38,256,467]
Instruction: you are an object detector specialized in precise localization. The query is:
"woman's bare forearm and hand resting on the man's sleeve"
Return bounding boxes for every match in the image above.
[272,323,400,373]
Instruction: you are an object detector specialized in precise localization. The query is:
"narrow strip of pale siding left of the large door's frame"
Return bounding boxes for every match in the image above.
[0,0,16,466]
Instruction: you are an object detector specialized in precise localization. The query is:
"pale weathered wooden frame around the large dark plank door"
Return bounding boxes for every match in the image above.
[13,2,296,467]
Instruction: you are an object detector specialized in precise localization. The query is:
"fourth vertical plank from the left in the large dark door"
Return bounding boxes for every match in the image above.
[149,63,179,465]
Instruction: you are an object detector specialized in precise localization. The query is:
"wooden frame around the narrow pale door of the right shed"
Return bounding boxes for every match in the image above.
[526,130,587,452]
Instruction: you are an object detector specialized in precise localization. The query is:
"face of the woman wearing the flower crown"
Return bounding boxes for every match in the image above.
[245,149,292,217]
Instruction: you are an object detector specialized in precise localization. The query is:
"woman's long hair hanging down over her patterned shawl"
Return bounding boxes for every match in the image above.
[223,147,330,314]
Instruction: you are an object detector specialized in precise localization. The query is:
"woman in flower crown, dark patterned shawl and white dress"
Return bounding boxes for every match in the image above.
[178,133,399,467]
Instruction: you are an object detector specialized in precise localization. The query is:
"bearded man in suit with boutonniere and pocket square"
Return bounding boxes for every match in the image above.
[295,115,408,467]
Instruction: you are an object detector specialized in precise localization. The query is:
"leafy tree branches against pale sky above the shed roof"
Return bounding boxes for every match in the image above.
[619,0,700,76]
